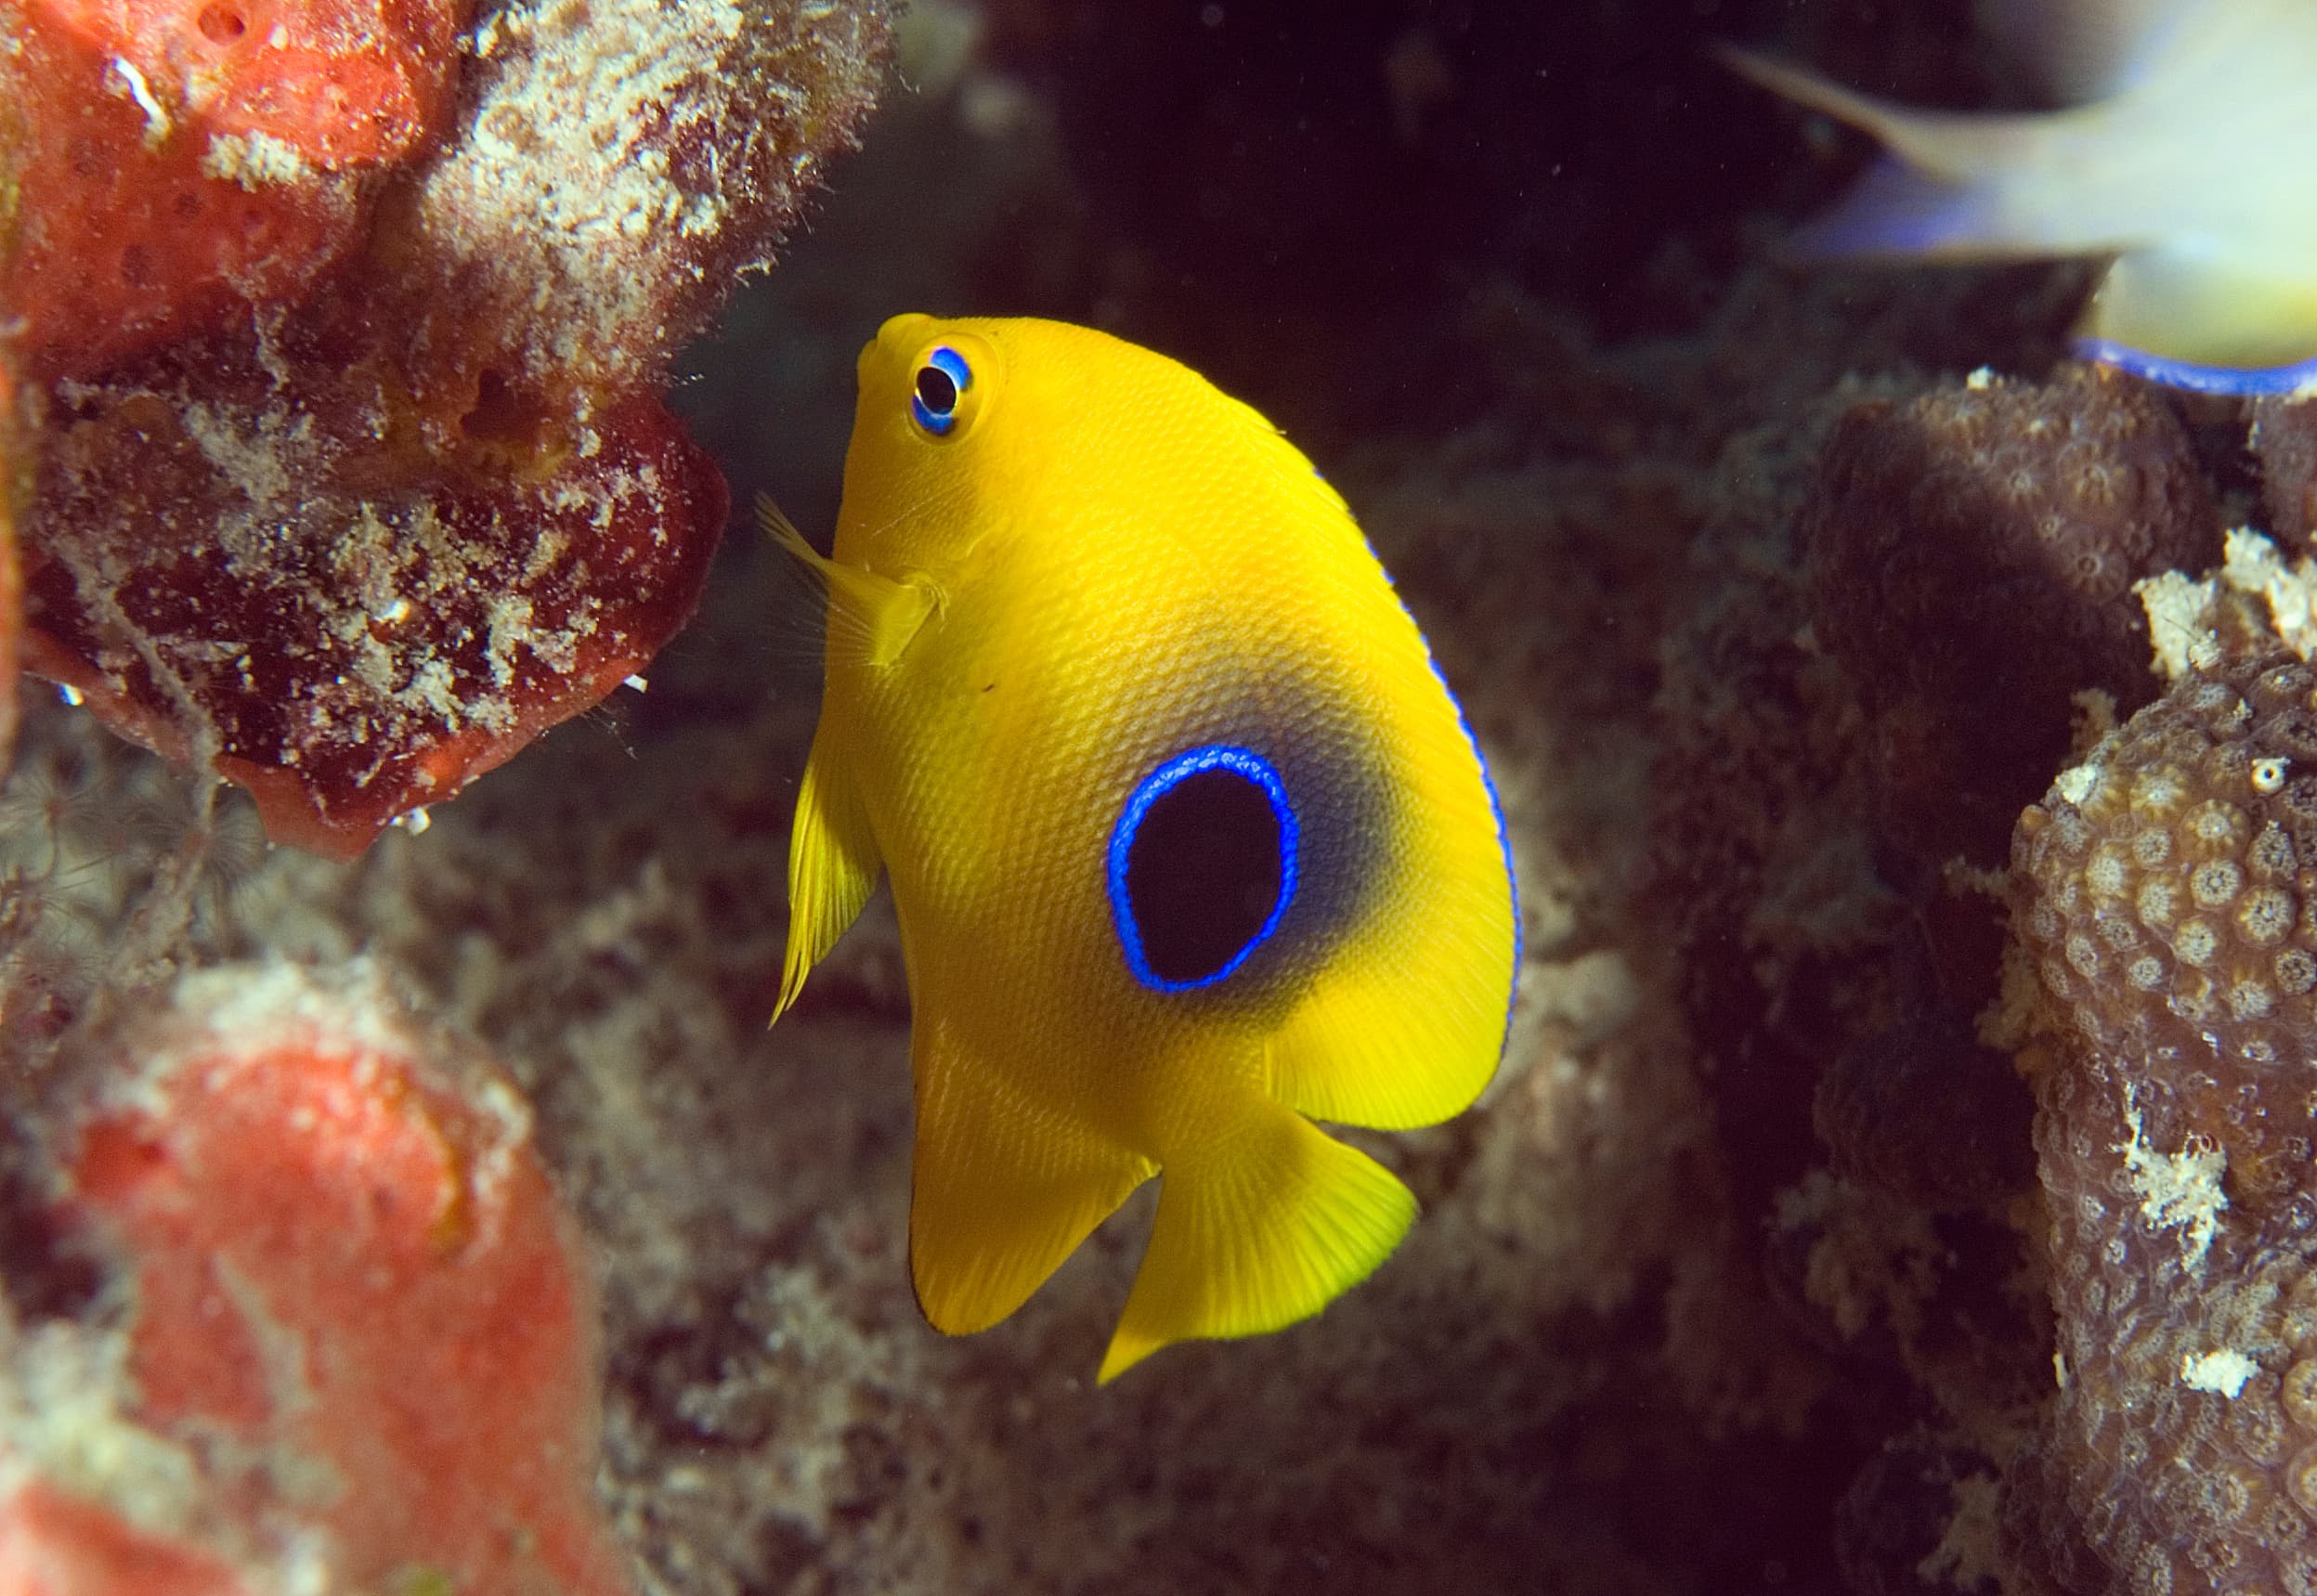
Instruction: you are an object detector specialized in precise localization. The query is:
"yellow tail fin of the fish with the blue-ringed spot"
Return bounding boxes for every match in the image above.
[1099,1098,1415,1382]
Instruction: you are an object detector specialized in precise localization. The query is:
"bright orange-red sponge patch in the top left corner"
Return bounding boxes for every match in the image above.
[0,0,463,378]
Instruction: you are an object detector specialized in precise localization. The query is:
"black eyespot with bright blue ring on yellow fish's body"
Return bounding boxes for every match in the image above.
[1110,748,1295,992]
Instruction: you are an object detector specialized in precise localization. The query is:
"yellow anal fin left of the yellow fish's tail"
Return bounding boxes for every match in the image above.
[908,1010,1156,1334]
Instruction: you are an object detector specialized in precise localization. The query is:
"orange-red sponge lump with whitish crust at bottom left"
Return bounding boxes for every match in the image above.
[0,966,631,1596]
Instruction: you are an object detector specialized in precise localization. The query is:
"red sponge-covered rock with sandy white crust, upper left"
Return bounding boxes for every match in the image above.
[0,0,885,855]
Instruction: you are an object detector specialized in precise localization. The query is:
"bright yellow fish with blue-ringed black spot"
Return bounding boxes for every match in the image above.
[764,315,1520,1381]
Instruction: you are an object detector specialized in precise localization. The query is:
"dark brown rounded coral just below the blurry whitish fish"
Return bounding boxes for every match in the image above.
[1803,366,2219,885]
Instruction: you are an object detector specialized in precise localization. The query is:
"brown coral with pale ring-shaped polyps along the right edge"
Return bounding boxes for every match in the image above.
[2009,655,2317,1596]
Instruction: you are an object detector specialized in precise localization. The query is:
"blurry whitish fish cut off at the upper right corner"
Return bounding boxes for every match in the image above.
[1726,0,2317,394]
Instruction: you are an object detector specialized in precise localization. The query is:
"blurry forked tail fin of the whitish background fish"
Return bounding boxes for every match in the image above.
[1714,46,2055,259]
